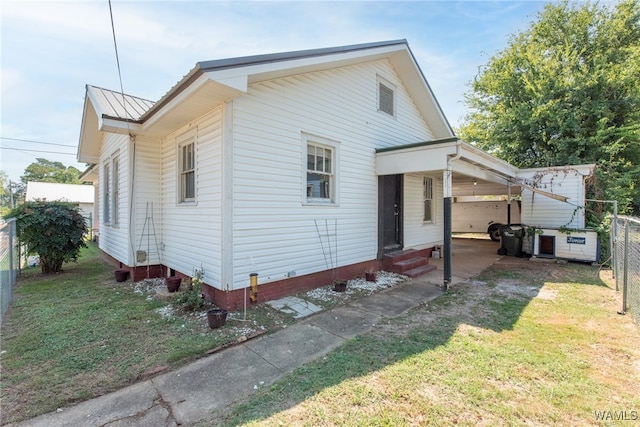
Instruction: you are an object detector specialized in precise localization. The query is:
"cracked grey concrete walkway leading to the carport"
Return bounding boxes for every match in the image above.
[12,242,501,427]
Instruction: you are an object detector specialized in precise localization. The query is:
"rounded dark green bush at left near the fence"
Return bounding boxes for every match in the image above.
[7,202,87,274]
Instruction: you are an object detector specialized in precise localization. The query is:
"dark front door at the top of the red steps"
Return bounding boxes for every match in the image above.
[378,175,402,253]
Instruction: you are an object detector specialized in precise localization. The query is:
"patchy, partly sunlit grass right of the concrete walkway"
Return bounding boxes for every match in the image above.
[208,260,640,426]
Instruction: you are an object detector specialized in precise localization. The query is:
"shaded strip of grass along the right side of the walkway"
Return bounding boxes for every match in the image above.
[211,259,607,426]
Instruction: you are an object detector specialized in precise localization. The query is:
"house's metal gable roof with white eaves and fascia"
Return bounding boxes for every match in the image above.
[78,39,454,163]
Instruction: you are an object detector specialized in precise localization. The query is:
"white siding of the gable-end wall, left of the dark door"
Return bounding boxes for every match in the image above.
[233,60,432,288]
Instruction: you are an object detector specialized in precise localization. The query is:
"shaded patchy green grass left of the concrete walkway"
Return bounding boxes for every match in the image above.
[0,244,291,423]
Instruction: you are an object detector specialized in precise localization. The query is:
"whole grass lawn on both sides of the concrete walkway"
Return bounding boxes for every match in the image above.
[0,244,640,426]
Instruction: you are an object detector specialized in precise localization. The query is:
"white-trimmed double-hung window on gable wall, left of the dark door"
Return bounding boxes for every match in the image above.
[304,135,337,203]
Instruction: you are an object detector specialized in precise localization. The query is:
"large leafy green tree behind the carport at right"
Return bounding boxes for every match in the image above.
[459,0,640,219]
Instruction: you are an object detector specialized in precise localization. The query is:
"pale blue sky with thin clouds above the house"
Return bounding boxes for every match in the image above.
[0,0,546,180]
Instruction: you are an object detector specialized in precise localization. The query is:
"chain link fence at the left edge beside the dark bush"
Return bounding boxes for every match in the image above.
[0,219,20,322]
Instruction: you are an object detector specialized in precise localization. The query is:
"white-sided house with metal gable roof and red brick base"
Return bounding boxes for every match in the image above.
[78,40,596,308]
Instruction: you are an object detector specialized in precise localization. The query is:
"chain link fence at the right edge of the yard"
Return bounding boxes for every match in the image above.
[611,216,640,324]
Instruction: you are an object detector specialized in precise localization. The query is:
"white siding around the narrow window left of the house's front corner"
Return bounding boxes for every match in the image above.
[161,106,224,289]
